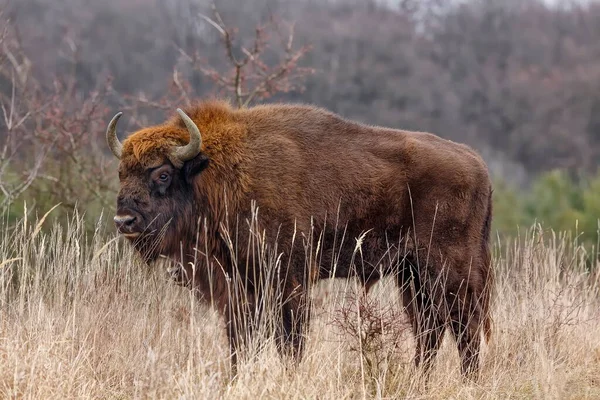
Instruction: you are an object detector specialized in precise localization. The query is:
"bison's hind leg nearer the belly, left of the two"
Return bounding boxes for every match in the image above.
[398,261,445,377]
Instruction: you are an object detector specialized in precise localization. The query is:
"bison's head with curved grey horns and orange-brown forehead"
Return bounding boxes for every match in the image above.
[106,109,208,260]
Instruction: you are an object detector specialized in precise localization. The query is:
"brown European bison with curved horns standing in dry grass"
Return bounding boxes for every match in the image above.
[106,101,493,378]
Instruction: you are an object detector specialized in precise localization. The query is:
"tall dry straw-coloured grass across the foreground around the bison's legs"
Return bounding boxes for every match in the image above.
[0,211,600,399]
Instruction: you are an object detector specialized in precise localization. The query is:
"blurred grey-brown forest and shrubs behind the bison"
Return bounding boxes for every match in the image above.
[0,0,600,253]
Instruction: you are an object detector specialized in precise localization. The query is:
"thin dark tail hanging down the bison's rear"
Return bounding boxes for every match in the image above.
[481,188,495,342]
